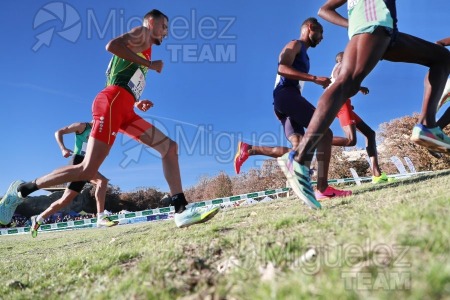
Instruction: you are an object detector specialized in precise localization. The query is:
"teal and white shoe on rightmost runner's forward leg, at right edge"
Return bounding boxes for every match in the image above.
[411,124,450,152]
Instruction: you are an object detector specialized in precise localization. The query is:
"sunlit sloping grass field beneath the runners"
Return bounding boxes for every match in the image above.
[0,172,450,299]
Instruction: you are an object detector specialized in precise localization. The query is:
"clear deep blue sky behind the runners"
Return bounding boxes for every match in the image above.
[0,0,450,194]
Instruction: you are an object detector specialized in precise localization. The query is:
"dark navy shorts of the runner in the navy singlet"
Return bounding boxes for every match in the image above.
[273,87,316,139]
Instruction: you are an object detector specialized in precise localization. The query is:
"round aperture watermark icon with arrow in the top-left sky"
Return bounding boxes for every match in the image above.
[32,2,81,52]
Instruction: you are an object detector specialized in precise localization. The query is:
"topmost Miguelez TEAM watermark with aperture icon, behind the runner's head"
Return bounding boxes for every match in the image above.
[32,2,237,63]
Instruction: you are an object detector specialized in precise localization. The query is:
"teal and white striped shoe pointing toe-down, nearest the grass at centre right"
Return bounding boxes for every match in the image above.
[277,151,322,209]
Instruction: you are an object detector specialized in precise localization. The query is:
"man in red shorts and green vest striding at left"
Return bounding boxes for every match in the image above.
[0,9,218,227]
